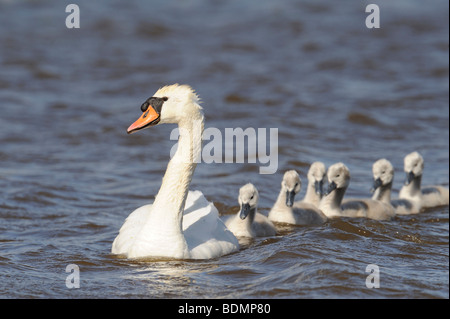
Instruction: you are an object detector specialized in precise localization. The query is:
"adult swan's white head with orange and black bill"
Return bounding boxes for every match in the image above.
[127,84,203,134]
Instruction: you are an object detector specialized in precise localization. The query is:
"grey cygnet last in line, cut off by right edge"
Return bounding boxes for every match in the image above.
[399,152,449,212]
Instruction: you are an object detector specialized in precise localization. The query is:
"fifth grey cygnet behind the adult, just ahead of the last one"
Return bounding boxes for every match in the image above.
[372,158,419,215]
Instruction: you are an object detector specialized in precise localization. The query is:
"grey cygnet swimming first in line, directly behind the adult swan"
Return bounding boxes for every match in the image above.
[225,183,276,238]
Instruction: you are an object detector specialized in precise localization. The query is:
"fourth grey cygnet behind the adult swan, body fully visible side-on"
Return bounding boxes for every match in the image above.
[320,163,395,220]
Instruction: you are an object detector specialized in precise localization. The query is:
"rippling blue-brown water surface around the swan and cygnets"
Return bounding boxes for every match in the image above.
[0,0,449,298]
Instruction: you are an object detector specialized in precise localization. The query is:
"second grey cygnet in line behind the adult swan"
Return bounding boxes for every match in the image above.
[269,170,327,225]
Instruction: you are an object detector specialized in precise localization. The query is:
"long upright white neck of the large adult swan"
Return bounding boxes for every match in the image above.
[134,114,204,258]
